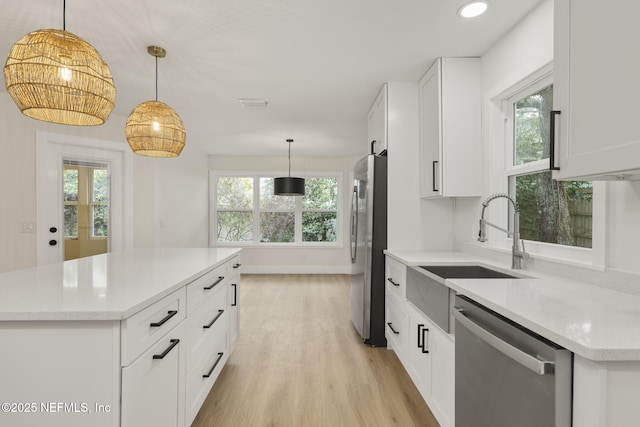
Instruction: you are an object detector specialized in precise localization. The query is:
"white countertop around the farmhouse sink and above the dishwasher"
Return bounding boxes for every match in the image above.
[386,251,640,361]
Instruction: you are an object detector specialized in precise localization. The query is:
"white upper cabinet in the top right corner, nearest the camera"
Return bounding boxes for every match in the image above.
[552,0,640,180]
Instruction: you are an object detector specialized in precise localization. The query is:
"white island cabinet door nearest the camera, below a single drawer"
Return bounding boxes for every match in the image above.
[122,331,185,427]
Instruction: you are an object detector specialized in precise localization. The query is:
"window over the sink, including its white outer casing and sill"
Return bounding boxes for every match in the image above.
[485,62,607,267]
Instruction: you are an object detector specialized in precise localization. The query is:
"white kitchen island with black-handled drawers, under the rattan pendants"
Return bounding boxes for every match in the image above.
[0,248,240,426]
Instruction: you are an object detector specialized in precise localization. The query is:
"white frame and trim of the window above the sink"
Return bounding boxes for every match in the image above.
[485,63,606,268]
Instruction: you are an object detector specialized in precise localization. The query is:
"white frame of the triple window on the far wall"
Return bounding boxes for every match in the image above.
[209,171,344,248]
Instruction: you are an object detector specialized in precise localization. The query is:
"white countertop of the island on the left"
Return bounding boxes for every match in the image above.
[0,248,240,321]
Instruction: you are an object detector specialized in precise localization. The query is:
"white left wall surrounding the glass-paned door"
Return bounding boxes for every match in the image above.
[0,92,208,272]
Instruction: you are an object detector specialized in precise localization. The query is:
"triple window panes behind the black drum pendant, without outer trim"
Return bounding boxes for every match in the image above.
[210,174,340,247]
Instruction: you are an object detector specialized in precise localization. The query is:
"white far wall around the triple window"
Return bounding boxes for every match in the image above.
[209,155,356,274]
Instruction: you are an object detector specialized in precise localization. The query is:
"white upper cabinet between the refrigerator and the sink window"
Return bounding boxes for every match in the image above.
[419,58,482,198]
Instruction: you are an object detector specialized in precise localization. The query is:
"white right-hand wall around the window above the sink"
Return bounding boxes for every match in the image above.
[455,0,640,290]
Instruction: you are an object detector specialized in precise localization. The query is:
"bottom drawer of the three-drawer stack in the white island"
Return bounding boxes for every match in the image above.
[186,331,228,425]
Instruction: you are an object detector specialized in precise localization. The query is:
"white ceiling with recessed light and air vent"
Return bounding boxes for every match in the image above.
[0,0,540,156]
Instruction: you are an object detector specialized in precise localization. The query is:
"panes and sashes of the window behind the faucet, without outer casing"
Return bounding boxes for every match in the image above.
[504,75,593,248]
